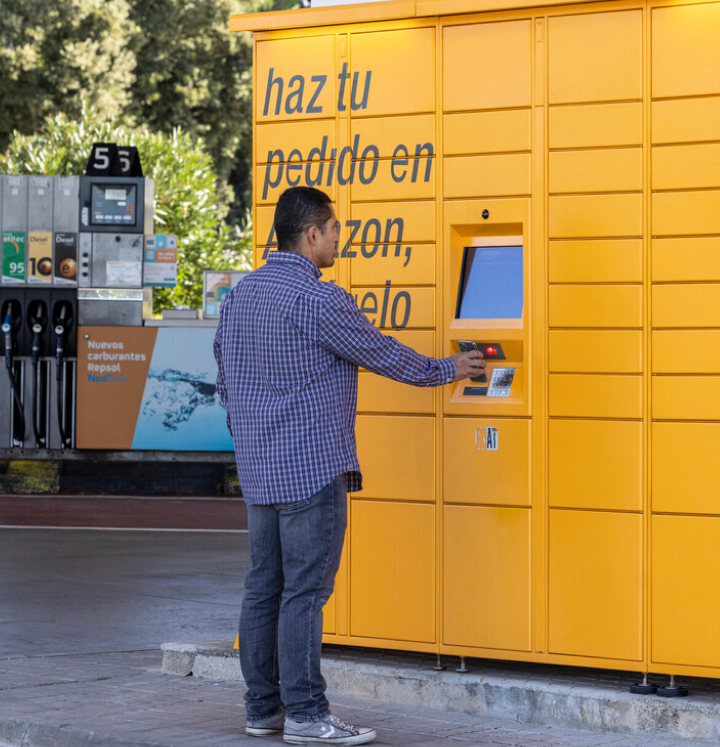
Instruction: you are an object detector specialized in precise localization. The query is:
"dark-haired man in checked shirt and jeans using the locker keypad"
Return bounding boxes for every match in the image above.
[215,187,485,745]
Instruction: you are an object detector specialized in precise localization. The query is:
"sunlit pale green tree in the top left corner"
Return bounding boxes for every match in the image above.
[0,0,141,151]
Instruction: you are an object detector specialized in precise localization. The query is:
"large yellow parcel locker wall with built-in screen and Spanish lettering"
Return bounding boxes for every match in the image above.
[231,0,720,677]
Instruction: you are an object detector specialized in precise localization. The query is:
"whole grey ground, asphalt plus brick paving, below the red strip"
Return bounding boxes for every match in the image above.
[0,529,708,747]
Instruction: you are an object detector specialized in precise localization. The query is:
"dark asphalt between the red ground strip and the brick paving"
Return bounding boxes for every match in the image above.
[0,528,249,656]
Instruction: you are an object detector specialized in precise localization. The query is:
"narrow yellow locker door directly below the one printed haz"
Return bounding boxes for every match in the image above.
[255,120,337,163]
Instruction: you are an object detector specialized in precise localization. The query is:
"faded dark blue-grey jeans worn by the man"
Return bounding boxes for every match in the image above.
[240,475,347,721]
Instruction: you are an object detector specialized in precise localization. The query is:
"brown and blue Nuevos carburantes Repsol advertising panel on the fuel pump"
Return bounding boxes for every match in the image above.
[76,327,232,451]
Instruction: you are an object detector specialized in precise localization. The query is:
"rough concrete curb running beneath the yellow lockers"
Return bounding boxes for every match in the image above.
[162,641,720,744]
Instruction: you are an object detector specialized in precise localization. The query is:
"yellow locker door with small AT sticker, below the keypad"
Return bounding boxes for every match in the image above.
[443,418,530,506]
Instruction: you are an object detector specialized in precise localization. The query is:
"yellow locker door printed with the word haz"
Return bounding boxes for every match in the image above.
[255,34,337,121]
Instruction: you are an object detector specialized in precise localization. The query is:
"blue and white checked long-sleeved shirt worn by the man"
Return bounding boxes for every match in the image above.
[214,251,456,505]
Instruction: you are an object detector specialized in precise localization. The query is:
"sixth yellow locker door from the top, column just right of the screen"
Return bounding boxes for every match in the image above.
[549,285,643,328]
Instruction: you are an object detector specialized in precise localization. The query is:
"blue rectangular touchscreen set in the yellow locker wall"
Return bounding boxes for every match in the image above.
[455,246,523,319]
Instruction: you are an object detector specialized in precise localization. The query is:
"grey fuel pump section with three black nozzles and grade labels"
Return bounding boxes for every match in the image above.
[0,176,79,449]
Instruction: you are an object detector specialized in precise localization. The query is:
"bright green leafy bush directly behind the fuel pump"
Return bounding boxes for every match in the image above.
[0,109,251,312]
